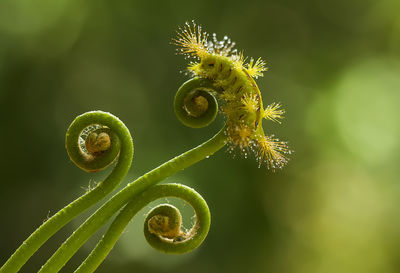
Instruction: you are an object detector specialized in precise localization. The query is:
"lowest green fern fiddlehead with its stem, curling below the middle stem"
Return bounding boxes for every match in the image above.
[75,184,211,273]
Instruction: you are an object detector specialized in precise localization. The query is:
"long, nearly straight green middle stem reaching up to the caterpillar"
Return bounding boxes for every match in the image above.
[39,127,227,273]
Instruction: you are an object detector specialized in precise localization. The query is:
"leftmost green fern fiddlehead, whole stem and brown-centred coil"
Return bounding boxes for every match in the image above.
[0,111,133,273]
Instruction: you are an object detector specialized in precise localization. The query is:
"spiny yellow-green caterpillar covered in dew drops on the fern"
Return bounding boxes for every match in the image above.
[172,21,292,169]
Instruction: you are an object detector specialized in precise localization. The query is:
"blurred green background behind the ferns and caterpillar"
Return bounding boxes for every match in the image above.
[0,0,400,273]
